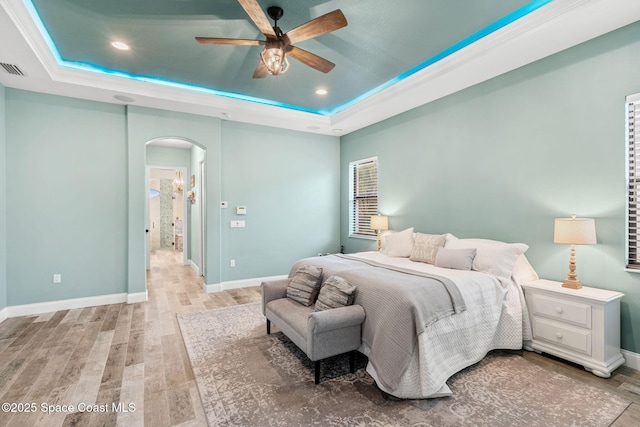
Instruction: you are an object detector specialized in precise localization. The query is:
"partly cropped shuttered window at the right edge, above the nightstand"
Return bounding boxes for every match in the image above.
[627,93,640,269]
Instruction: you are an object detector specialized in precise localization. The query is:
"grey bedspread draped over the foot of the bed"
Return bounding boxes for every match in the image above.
[289,254,466,390]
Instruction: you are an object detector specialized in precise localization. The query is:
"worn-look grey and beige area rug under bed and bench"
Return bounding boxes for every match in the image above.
[178,303,629,427]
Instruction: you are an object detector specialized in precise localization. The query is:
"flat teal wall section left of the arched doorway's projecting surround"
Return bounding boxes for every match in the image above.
[3,88,127,306]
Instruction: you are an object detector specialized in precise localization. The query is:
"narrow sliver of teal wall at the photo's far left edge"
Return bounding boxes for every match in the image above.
[0,84,7,310]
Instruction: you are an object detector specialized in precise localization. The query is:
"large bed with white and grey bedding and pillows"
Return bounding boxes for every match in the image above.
[290,229,537,398]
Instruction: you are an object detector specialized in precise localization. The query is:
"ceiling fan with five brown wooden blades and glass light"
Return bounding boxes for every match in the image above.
[196,0,347,79]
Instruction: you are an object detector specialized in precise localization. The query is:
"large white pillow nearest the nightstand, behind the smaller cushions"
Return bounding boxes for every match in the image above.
[445,239,529,278]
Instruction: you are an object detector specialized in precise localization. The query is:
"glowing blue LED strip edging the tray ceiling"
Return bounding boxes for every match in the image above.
[24,0,553,116]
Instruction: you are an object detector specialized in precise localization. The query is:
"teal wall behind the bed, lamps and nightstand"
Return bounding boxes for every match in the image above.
[341,23,640,352]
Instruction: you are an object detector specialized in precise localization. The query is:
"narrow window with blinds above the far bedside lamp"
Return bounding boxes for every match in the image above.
[349,157,378,238]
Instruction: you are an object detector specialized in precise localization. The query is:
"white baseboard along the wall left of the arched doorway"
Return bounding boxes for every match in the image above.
[0,291,148,319]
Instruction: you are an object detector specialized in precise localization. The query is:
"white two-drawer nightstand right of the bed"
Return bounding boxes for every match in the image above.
[522,280,624,378]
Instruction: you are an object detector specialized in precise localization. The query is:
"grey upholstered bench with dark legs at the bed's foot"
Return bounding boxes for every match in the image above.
[261,279,365,384]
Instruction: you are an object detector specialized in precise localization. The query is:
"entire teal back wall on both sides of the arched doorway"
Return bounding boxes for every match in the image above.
[0,93,340,309]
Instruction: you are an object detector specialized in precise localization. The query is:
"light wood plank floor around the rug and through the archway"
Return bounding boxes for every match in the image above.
[0,251,640,427]
